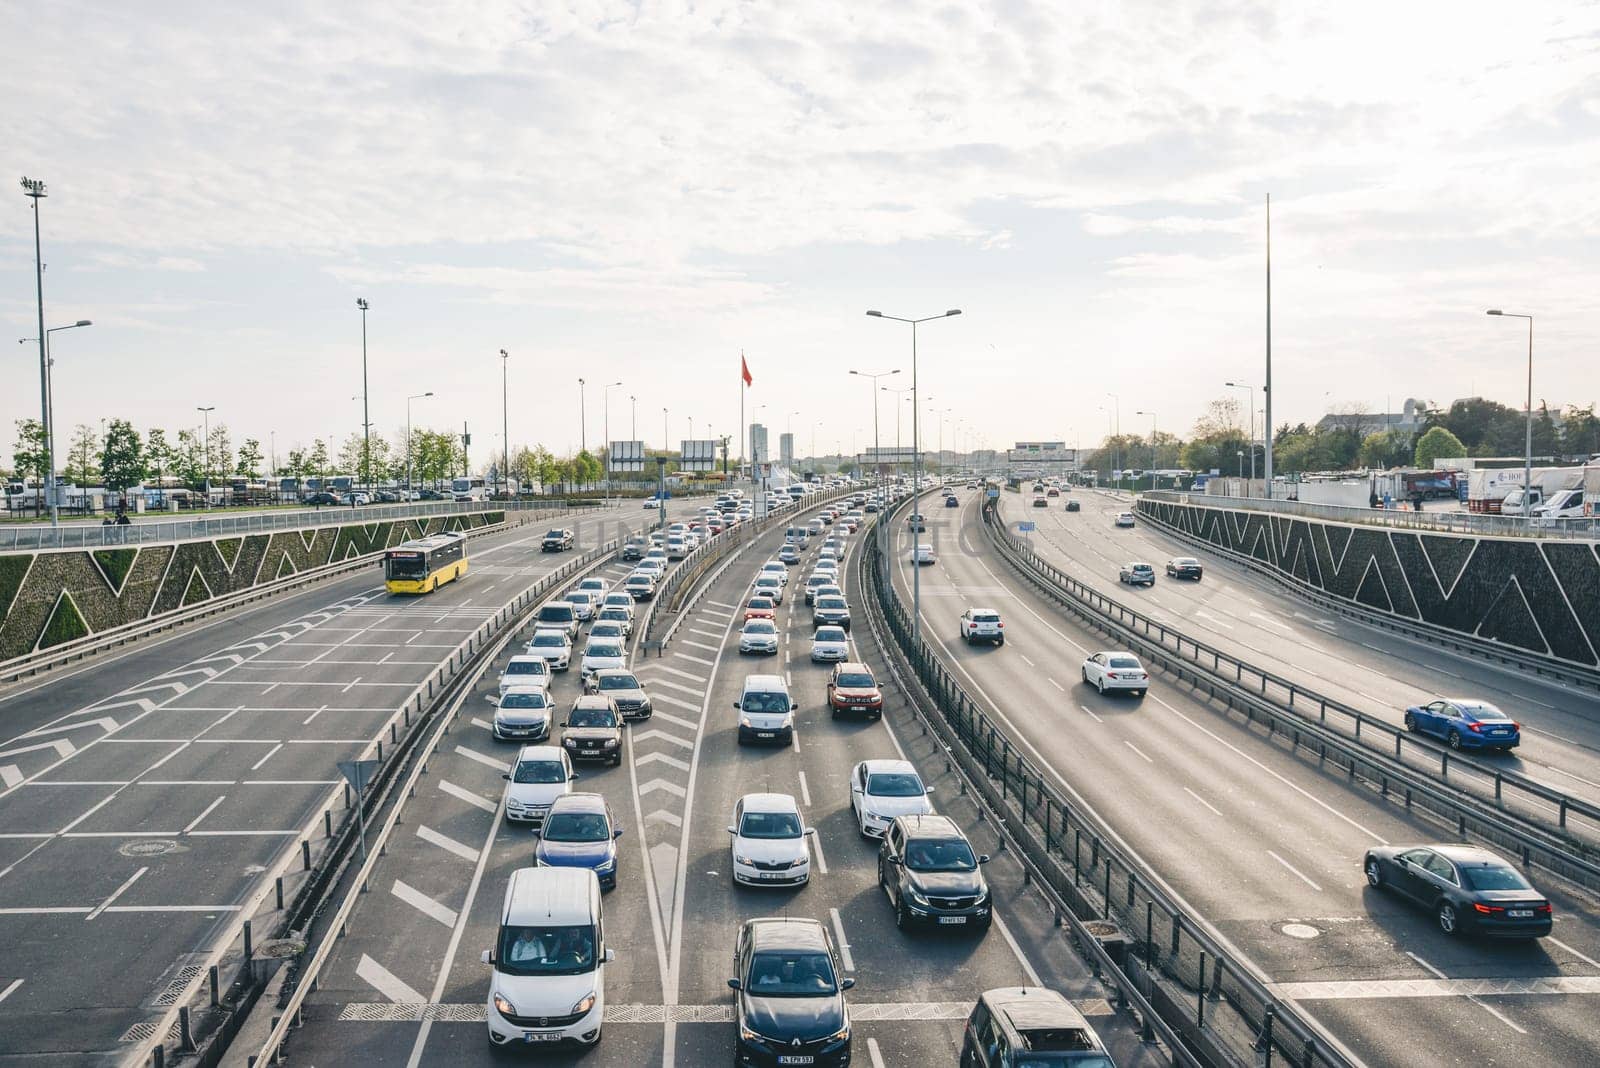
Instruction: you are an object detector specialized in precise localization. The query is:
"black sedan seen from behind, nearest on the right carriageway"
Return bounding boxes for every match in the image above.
[1362,844,1554,938]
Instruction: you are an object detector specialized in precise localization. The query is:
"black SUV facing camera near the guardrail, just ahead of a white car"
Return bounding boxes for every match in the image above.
[878,815,994,931]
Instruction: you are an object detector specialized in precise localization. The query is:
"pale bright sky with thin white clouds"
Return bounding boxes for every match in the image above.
[0,0,1600,470]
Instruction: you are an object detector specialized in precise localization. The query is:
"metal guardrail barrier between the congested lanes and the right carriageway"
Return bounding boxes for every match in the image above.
[861,495,1360,1068]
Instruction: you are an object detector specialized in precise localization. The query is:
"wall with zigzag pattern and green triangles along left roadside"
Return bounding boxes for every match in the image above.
[0,512,506,660]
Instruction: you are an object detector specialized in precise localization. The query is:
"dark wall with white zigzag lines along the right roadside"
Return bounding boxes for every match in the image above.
[1139,500,1600,667]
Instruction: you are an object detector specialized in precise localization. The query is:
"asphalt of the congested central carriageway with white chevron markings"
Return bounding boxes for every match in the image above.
[265,512,1165,1068]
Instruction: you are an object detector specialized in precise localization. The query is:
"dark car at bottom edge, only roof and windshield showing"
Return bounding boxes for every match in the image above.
[962,986,1115,1068]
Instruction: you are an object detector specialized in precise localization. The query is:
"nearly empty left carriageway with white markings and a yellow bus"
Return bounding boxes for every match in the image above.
[0,505,683,1065]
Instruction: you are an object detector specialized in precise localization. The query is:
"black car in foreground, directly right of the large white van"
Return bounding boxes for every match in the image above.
[728,918,856,1068]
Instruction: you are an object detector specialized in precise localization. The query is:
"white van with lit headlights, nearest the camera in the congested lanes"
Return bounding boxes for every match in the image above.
[482,868,616,1049]
